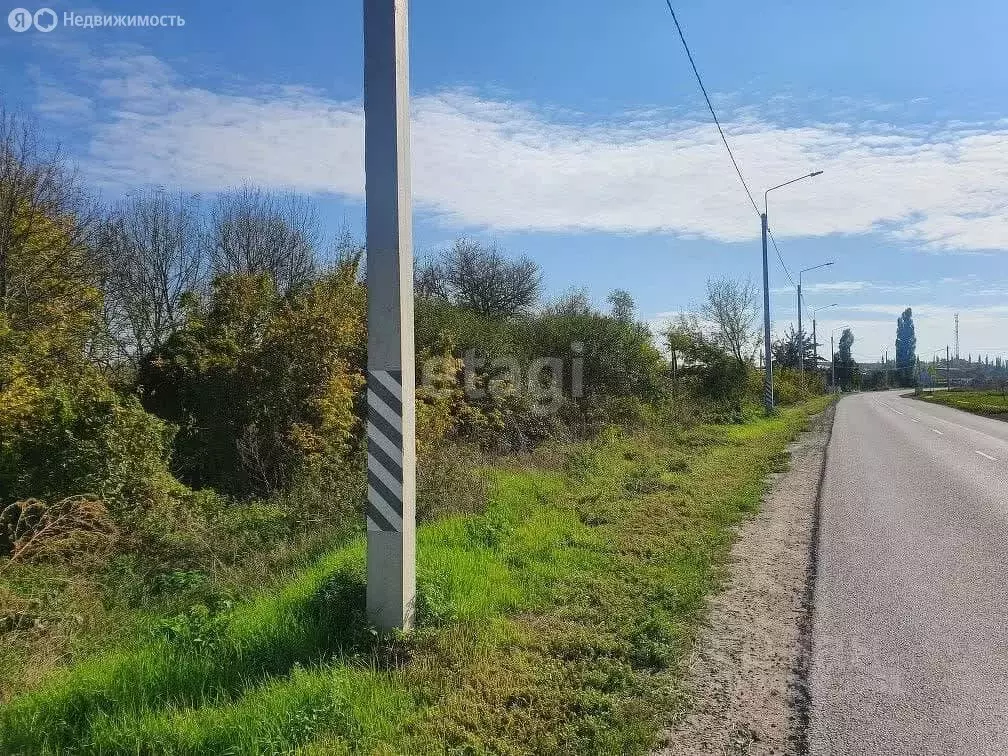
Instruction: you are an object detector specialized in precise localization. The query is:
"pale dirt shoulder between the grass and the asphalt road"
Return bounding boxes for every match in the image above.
[657,405,836,756]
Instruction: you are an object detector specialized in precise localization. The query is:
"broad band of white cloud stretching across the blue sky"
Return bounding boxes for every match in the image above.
[31,45,1008,253]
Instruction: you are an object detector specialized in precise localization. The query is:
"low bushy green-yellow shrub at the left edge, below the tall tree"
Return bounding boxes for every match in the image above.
[0,314,188,568]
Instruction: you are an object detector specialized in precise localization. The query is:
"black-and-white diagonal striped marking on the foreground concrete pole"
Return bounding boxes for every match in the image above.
[367,370,403,532]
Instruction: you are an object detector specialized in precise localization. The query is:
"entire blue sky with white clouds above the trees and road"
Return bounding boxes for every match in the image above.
[0,0,1008,360]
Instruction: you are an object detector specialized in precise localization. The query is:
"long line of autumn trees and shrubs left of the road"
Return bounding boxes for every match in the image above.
[0,105,826,580]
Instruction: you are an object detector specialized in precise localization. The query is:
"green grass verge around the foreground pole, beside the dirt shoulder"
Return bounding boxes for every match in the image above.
[0,399,828,754]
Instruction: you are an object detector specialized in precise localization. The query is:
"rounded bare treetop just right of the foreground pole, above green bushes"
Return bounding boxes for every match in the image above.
[417,238,542,318]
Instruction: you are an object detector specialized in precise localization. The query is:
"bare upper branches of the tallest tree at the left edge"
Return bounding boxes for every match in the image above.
[0,106,98,328]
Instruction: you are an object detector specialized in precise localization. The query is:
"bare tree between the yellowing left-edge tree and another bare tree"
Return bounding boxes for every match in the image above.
[99,190,209,365]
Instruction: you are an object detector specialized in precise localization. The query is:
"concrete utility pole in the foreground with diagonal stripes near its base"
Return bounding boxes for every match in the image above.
[364,0,416,630]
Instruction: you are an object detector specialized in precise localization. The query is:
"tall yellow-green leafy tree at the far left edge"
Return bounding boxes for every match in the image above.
[0,132,187,546]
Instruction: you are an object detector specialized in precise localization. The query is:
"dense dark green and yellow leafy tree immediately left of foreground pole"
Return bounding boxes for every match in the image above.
[137,264,365,493]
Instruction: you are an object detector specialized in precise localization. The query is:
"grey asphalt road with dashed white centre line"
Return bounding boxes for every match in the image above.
[808,392,1008,756]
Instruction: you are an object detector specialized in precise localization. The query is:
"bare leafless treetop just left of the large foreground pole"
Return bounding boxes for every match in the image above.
[208,184,321,293]
